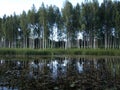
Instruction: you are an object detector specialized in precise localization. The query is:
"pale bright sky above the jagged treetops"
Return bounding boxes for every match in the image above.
[0,0,103,17]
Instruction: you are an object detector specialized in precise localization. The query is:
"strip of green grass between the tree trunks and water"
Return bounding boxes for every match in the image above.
[0,48,120,56]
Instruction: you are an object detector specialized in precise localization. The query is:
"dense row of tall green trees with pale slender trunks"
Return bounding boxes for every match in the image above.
[0,0,120,49]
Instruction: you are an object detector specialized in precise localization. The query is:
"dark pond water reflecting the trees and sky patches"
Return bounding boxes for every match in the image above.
[0,57,120,90]
